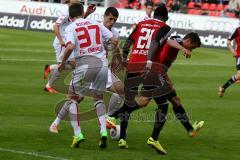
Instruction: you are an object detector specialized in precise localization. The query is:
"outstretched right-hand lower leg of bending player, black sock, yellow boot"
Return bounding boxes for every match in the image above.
[167,90,204,137]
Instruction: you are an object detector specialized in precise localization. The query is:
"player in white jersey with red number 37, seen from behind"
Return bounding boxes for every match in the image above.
[58,4,116,148]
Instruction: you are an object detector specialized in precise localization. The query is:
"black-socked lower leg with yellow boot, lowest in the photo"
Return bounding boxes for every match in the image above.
[147,96,168,155]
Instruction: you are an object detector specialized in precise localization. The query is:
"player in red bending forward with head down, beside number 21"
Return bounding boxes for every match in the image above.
[110,33,204,154]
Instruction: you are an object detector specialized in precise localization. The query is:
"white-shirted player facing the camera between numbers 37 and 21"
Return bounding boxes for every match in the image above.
[49,7,124,133]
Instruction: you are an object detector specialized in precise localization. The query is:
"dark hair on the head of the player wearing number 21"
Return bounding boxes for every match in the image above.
[153,3,168,21]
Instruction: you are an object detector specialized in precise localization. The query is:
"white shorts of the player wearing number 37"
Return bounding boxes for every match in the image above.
[69,56,108,96]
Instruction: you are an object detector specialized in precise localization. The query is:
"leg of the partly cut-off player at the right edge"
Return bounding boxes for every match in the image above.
[218,58,240,97]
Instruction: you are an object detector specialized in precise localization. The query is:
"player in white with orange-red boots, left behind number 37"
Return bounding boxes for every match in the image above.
[44,0,96,93]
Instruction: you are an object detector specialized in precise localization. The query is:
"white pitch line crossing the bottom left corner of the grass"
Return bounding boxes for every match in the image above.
[0,148,68,160]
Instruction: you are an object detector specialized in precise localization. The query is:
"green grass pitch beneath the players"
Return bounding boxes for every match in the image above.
[0,28,240,160]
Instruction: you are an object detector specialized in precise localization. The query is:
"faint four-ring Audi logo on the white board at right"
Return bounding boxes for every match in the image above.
[204,20,233,32]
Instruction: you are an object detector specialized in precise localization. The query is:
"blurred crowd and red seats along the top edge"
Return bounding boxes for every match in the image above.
[29,0,240,18]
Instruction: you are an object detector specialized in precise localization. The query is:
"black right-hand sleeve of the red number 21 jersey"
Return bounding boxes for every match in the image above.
[153,25,172,45]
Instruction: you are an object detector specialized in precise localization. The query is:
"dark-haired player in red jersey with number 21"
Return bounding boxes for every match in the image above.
[111,4,190,154]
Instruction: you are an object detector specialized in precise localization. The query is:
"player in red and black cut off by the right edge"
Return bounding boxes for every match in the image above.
[218,27,240,97]
